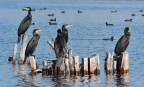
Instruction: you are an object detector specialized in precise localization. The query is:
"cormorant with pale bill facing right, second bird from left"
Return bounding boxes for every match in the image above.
[23,29,41,64]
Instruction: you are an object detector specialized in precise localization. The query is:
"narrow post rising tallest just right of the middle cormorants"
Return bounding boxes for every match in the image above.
[68,49,74,74]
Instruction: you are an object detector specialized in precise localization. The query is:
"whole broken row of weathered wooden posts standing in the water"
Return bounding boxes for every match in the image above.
[9,35,129,76]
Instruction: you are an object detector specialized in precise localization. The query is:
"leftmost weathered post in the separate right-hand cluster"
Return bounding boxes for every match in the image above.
[105,52,113,74]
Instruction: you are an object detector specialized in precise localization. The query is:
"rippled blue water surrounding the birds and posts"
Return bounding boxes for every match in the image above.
[0,0,144,87]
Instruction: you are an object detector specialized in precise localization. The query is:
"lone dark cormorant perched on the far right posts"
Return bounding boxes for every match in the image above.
[114,27,131,56]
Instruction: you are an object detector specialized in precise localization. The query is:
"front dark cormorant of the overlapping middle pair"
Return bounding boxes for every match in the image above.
[54,29,66,58]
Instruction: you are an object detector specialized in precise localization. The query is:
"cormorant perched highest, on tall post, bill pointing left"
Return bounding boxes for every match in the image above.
[17,7,32,43]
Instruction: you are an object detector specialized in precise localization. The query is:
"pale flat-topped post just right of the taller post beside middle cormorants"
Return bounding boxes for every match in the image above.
[73,56,80,75]
